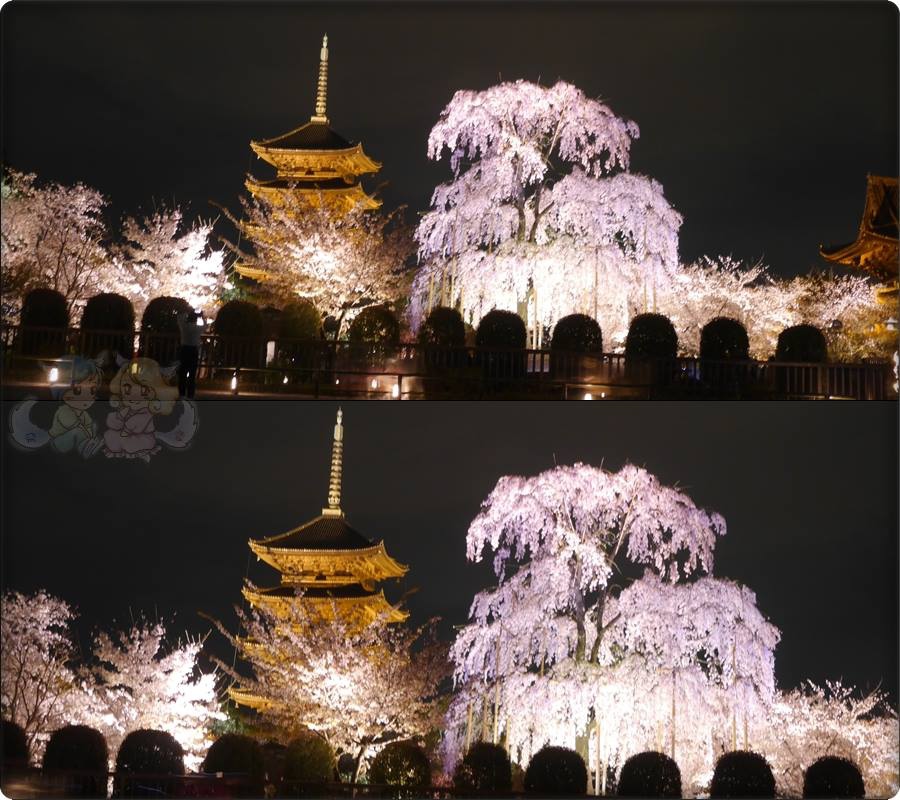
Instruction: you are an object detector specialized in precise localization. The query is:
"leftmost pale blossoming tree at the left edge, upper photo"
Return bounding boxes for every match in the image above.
[0,169,123,321]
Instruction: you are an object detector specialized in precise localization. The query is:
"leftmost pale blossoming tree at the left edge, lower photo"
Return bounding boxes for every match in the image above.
[0,591,81,757]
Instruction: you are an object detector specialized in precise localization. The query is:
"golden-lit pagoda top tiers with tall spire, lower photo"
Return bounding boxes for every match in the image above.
[243,409,408,625]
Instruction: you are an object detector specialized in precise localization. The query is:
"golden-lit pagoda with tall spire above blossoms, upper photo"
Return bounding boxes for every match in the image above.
[235,35,381,280]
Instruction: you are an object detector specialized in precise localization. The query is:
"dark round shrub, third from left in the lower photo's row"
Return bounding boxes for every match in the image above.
[113,728,184,797]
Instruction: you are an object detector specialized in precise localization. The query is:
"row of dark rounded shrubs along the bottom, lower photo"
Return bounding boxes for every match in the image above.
[2,721,865,798]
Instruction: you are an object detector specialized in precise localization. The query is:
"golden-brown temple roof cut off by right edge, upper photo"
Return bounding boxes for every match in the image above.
[819,175,900,316]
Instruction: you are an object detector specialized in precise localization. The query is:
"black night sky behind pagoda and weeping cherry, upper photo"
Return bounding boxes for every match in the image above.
[2,2,898,275]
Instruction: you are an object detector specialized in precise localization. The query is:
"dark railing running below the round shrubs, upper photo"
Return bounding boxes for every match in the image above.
[0,326,896,400]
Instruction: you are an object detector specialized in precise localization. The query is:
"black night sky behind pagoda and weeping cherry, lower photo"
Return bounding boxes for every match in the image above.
[2,401,898,702]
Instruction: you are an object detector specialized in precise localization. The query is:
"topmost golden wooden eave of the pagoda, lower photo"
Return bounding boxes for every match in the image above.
[249,539,409,581]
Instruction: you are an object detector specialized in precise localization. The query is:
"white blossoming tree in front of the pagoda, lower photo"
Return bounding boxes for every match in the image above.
[216,602,447,777]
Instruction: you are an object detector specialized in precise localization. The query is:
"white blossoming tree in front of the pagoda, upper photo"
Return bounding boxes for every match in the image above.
[224,192,412,332]
